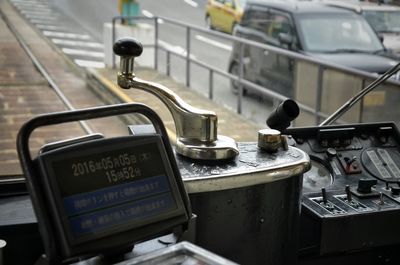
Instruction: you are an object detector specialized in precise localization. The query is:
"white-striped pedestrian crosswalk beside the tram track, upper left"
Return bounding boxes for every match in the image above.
[10,0,105,68]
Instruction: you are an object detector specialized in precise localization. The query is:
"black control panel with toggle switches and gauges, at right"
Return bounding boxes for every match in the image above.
[285,123,400,255]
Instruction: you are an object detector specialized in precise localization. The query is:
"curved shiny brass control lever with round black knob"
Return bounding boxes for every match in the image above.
[113,38,239,160]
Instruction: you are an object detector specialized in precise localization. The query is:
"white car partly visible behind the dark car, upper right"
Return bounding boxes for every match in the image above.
[323,0,400,55]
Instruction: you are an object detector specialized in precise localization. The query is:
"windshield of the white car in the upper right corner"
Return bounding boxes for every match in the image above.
[363,10,400,33]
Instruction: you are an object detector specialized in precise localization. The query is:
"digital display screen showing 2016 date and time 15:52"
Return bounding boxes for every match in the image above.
[39,136,183,243]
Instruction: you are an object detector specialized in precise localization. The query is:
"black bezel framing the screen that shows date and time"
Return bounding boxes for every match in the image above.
[37,135,187,249]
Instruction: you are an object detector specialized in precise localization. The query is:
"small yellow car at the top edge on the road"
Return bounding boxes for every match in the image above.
[206,0,246,33]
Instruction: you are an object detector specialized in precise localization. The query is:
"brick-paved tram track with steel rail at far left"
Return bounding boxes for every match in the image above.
[0,1,127,177]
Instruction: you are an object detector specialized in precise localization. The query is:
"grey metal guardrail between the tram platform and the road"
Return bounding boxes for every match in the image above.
[112,16,400,124]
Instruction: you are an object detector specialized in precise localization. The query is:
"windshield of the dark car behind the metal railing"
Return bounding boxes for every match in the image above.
[299,14,383,53]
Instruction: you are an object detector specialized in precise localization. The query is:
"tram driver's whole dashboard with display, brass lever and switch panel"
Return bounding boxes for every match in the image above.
[2,38,400,265]
